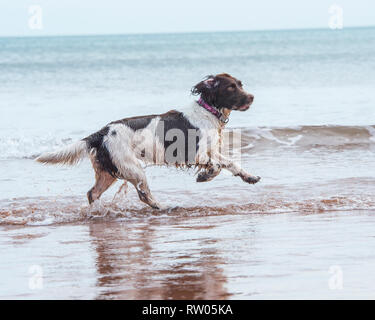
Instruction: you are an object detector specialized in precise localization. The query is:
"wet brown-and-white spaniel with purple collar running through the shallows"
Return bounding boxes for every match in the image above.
[36,73,260,209]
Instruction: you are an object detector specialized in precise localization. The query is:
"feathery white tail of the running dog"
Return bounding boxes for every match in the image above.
[35,140,88,165]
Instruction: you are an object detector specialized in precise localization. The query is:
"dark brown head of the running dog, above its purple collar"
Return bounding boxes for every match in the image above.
[191,73,254,111]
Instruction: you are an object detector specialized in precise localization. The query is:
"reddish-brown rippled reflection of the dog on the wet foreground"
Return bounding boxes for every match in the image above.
[90,219,229,299]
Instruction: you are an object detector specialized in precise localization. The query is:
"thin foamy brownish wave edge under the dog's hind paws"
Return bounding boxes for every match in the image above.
[0,195,375,225]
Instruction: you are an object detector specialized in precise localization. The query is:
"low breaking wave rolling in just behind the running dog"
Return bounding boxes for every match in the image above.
[0,125,375,160]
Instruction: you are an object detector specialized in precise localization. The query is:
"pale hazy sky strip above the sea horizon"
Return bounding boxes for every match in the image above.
[0,0,375,36]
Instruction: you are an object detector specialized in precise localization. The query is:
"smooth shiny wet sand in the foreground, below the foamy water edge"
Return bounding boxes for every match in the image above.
[0,210,375,299]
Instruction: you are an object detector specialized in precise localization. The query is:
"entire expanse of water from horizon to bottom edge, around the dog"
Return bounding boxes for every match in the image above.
[0,28,375,299]
